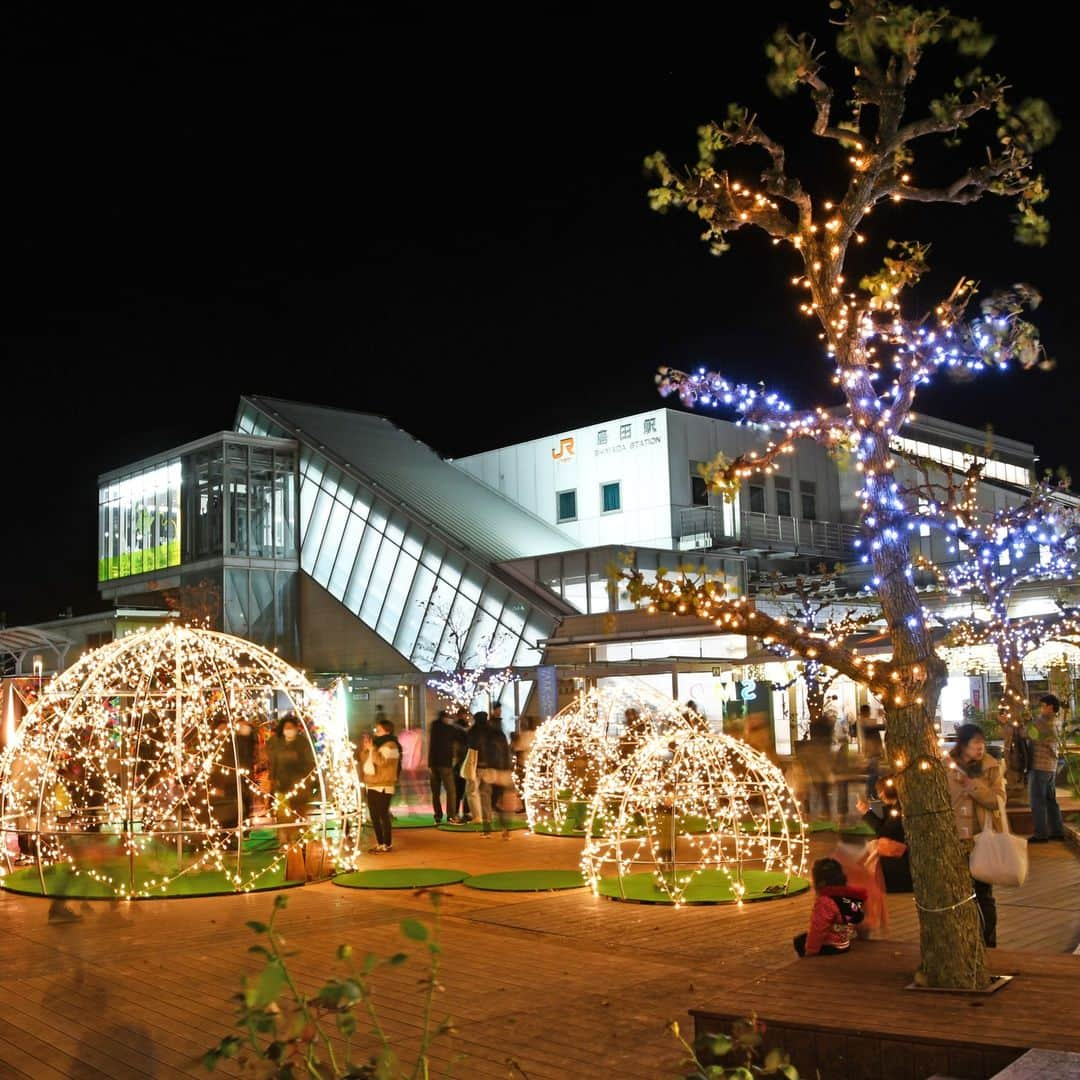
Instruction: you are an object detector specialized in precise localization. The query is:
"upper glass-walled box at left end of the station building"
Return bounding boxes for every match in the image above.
[97,440,297,581]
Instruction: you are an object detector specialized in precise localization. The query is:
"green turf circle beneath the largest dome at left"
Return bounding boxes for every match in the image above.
[0,851,303,900]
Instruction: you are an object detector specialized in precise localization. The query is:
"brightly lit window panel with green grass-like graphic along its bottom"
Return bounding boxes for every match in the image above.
[97,458,181,581]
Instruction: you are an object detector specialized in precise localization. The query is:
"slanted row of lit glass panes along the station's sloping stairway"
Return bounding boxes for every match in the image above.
[235,397,554,673]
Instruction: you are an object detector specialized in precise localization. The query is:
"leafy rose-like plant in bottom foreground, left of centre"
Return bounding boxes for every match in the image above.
[202,892,461,1080]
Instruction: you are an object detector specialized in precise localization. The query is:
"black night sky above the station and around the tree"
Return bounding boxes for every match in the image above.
[0,2,1080,625]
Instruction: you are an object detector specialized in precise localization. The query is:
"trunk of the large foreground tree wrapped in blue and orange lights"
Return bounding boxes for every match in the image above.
[841,362,989,989]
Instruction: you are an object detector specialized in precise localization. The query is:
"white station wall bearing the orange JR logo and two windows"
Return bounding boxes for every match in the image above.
[454,408,676,549]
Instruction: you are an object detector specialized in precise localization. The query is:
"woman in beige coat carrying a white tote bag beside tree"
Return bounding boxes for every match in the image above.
[948,724,1005,948]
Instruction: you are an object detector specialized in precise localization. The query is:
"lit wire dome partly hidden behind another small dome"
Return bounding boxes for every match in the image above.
[518,683,687,836]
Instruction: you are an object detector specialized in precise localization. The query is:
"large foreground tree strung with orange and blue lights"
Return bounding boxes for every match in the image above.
[630,0,1056,987]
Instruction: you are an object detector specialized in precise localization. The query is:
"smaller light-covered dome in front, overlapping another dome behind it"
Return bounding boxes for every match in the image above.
[581,727,808,905]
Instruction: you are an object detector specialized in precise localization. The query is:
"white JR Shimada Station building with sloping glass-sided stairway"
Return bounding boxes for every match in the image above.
[0,395,1077,756]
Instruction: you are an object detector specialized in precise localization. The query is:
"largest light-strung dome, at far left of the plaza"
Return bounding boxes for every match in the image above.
[0,624,361,899]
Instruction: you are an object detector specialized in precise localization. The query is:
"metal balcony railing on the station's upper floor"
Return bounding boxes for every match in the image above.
[679,507,859,558]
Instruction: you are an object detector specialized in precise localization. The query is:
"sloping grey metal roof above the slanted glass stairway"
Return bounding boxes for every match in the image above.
[239,395,580,564]
